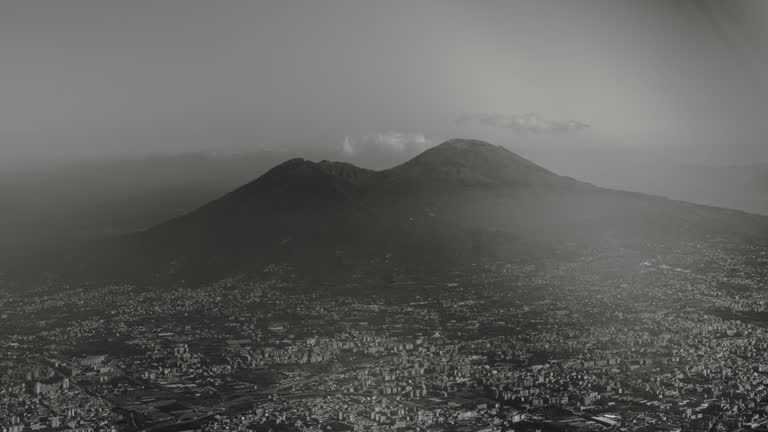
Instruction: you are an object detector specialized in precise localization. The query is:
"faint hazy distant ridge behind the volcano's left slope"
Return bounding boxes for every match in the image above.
[0,151,298,268]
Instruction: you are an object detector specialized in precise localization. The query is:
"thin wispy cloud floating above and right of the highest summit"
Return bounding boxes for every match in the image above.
[457,114,589,134]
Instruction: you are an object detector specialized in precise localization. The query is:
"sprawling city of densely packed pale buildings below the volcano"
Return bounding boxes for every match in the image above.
[0,241,768,432]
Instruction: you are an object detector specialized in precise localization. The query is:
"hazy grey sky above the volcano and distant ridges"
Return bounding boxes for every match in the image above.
[0,0,768,167]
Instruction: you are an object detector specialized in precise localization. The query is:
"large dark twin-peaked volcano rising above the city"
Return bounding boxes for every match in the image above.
[43,139,768,286]
